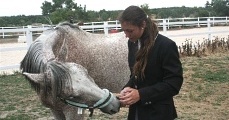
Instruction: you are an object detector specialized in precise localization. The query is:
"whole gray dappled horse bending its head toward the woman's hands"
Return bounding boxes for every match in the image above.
[21,23,130,120]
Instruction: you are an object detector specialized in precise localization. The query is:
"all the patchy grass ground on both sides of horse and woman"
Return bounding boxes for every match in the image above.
[0,53,229,120]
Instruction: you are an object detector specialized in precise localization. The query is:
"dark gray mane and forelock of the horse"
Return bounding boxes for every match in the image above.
[20,28,71,96]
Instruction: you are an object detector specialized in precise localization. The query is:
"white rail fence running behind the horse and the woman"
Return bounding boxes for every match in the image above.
[0,17,229,71]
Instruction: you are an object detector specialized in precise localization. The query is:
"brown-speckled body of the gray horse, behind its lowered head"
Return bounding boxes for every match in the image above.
[65,31,129,92]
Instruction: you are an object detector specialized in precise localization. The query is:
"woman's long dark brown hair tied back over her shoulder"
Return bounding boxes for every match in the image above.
[119,6,158,79]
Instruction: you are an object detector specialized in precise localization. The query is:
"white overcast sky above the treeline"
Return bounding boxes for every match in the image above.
[0,0,211,16]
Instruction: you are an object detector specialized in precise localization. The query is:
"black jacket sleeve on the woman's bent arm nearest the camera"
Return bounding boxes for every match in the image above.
[139,42,183,104]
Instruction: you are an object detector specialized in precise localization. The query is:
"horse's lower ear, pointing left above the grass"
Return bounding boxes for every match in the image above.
[23,72,45,84]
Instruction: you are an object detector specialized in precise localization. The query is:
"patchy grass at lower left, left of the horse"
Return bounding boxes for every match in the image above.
[0,73,50,120]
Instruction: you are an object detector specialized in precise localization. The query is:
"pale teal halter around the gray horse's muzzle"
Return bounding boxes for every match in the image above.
[60,89,114,117]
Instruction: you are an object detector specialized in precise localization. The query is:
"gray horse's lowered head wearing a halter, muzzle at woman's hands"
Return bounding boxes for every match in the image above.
[23,60,120,114]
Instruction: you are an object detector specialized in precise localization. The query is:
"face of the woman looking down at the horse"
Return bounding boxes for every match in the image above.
[121,21,144,42]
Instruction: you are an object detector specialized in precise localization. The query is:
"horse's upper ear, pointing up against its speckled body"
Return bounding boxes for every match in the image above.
[56,39,68,62]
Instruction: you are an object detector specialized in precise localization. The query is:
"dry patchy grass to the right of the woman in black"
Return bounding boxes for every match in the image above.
[175,53,229,120]
